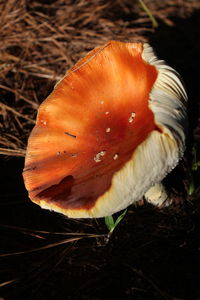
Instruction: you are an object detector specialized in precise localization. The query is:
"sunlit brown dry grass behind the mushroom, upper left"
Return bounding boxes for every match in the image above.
[0,0,200,156]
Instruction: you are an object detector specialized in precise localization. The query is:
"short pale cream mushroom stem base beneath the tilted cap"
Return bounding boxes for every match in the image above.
[144,182,169,207]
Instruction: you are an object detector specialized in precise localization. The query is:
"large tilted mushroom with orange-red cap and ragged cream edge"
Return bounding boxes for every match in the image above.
[23,41,187,218]
